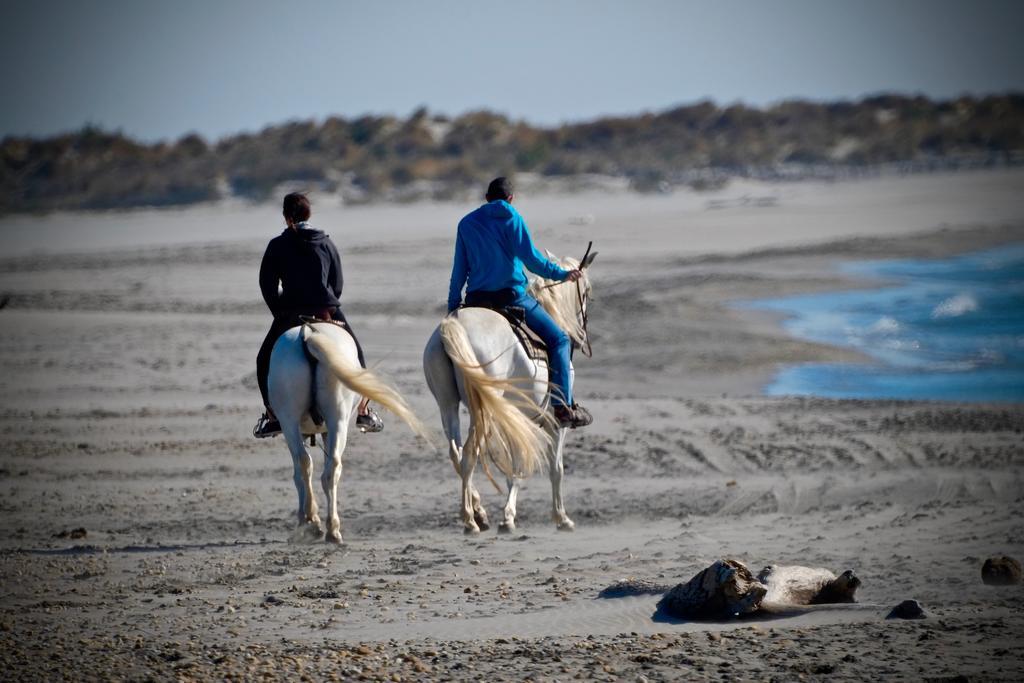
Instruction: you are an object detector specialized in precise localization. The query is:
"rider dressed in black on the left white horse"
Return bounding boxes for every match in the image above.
[253,193,384,438]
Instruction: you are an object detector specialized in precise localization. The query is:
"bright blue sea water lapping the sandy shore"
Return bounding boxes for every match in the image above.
[746,244,1024,401]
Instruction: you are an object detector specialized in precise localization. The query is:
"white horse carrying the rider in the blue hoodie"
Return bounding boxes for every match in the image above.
[423,254,596,533]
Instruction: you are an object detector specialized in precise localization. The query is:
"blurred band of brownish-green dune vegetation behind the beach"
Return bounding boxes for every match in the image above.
[0,94,1024,213]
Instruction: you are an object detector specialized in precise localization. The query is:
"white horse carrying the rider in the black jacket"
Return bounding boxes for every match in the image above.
[267,322,430,543]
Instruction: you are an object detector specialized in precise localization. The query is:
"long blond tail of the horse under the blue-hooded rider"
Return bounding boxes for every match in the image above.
[440,317,551,481]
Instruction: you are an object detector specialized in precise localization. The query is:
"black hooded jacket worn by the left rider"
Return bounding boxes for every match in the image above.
[259,223,343,316]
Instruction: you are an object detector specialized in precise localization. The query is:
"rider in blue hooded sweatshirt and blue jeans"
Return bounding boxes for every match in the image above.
[447,177,594,428]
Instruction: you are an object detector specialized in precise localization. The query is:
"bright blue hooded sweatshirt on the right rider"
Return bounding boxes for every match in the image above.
[449,200,569,311]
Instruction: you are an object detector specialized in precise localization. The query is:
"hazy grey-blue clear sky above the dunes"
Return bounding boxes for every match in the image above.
[0,0,1024,141]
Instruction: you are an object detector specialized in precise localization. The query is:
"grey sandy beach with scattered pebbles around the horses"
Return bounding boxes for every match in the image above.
[0,171,1024,681]
